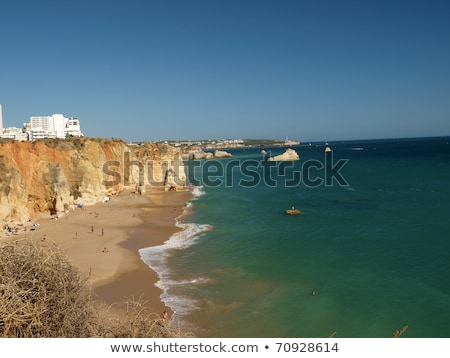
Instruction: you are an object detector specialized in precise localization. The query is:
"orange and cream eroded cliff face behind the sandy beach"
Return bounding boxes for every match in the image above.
[0,138,186,225]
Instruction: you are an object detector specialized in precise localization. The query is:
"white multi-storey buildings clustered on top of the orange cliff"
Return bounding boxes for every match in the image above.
[0,104,83,141]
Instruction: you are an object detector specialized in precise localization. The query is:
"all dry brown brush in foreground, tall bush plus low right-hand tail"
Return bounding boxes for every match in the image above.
[0,239,190,338]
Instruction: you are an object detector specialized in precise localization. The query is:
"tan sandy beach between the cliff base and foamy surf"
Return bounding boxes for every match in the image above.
[5,188,191,314]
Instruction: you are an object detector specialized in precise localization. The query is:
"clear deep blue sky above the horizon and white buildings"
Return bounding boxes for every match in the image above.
[0,0,450,142]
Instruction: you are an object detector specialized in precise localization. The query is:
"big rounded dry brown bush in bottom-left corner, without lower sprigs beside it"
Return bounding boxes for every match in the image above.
[0,239,96,337]
